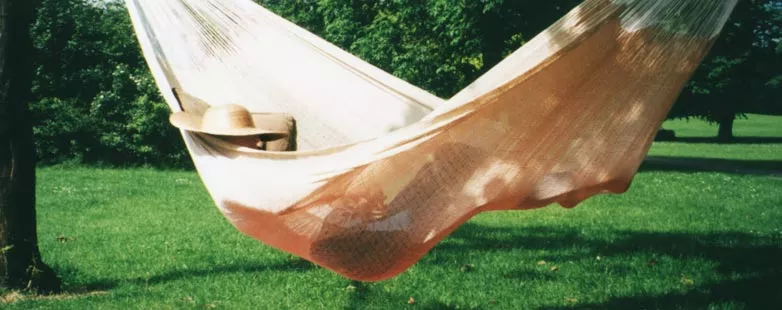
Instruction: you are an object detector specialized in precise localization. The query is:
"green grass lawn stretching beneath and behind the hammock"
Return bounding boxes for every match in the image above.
[6,118,782,309]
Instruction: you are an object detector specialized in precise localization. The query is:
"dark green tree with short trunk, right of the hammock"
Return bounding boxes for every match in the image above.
[671,0,782,140]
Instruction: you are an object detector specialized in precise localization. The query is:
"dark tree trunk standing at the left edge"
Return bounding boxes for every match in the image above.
[0,0,60,292]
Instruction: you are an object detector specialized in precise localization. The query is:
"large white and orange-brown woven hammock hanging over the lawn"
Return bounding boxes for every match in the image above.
[126,0,736,281]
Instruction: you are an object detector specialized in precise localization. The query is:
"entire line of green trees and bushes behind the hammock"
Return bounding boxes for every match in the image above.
[31,0,782,167]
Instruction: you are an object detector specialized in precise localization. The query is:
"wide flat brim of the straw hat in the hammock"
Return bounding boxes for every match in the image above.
[169,112,288,138]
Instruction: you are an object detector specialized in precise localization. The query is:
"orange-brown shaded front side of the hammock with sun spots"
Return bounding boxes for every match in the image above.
[201,3,736,281]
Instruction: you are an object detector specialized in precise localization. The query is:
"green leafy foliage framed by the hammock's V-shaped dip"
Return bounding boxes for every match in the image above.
[258,0,580,97]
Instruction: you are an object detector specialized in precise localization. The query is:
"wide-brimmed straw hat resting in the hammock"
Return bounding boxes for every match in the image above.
[169,104,288,138]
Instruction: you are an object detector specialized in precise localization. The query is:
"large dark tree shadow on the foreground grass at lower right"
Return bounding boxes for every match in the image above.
[432,222,782,309]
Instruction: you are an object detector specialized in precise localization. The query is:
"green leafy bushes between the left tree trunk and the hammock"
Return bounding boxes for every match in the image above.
[31,0,188,166]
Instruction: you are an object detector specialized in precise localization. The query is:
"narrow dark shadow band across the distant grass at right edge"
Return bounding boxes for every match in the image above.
[640,156,782,176]
